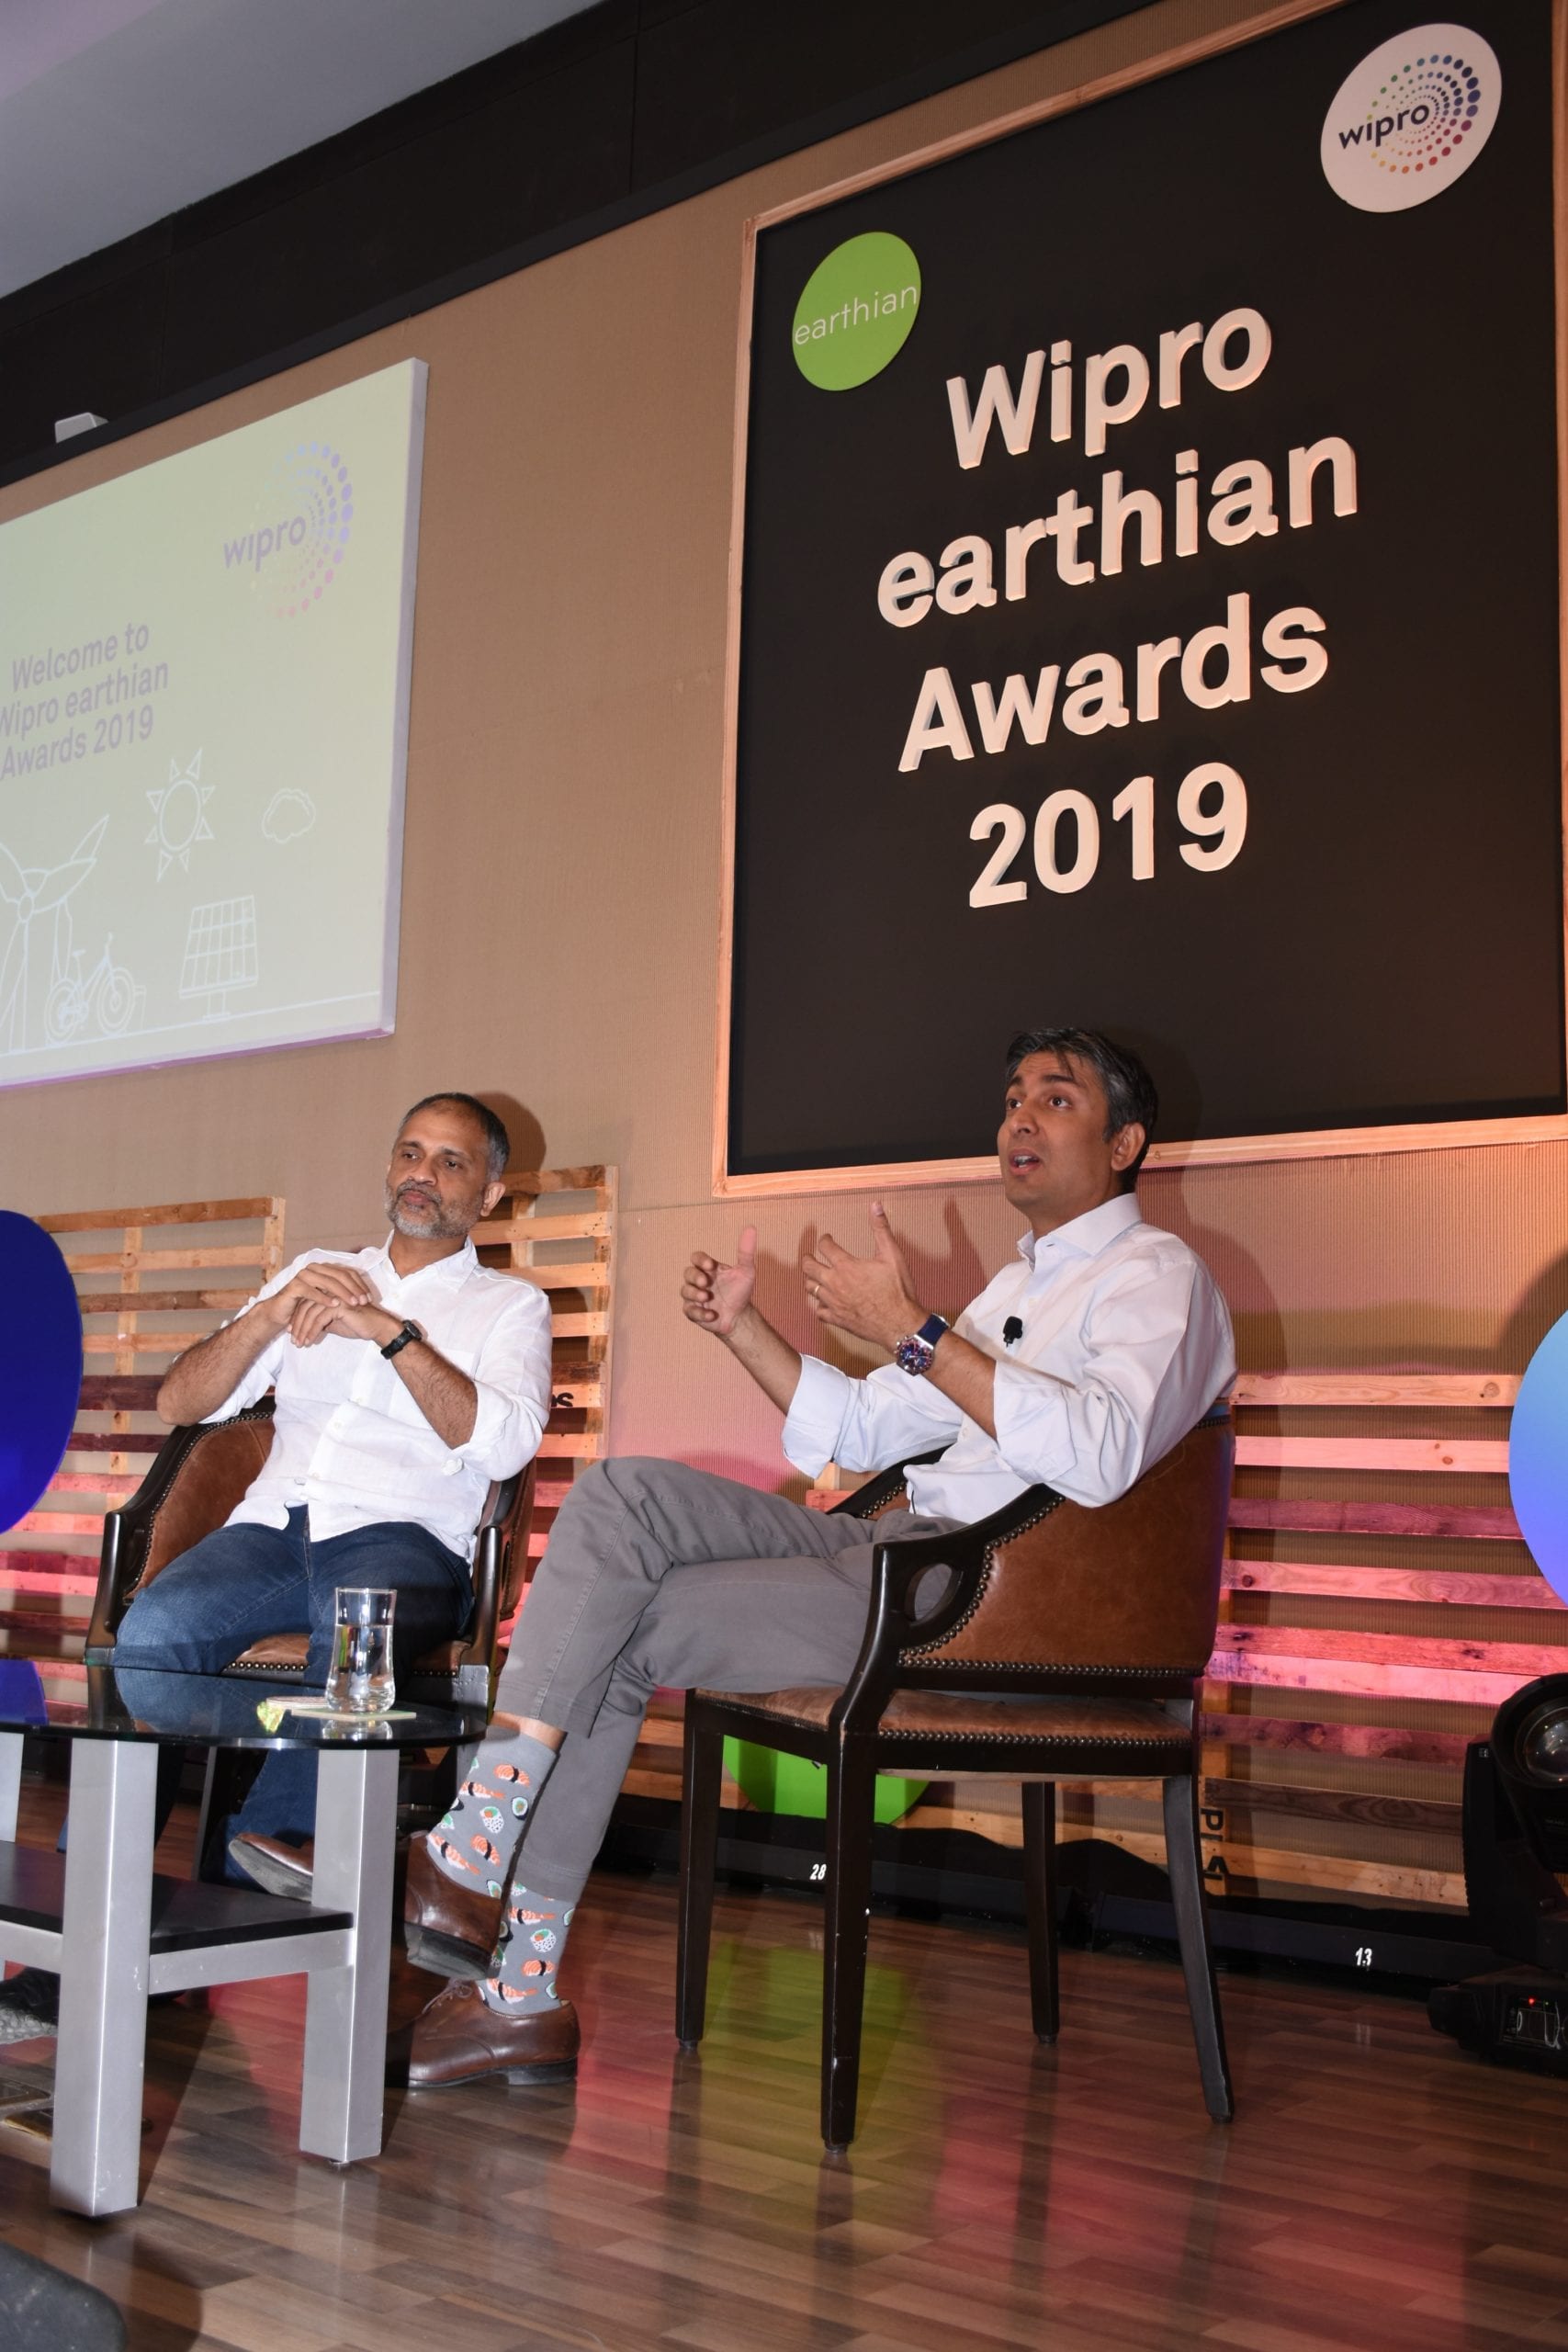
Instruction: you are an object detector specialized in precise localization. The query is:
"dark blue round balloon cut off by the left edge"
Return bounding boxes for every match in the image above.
[0,1209,83,1529]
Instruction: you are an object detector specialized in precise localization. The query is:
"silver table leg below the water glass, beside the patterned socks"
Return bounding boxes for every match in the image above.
[299,1747,398,2164]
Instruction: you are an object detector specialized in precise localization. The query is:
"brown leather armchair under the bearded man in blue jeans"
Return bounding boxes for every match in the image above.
[87,1397,534,1708]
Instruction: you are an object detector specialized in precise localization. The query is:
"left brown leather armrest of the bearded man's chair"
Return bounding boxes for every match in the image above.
[85,1397,273,1665]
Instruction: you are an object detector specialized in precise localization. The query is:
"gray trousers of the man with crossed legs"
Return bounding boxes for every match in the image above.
[496,1456,959,1903]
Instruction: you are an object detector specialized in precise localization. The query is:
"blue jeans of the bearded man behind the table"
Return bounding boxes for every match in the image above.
[115,1505,472,1837]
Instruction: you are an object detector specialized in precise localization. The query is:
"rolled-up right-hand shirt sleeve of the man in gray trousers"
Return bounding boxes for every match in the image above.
[992,1256,1235,1505]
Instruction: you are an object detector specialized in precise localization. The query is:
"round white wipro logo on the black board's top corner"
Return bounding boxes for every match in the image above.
[1321,24,1502,211]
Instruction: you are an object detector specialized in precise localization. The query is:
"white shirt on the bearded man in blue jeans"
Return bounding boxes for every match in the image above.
[207,1242,550,1559]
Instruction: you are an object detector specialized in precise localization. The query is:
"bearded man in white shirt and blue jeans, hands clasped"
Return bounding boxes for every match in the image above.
[115,1093,550,1894]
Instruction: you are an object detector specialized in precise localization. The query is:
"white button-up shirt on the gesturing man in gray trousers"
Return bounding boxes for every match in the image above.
[783,1193,1236,1524]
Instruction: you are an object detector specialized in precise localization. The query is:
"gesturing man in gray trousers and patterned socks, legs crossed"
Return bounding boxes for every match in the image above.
[407,1028,1236,2088]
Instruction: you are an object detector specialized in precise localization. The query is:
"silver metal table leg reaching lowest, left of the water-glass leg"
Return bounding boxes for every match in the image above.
[50,1740,157,2213]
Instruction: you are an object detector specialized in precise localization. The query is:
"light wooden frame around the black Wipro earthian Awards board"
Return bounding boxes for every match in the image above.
[712,0,1568,1197]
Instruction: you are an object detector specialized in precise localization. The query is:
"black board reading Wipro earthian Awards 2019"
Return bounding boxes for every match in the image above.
[717,0,1568,1188]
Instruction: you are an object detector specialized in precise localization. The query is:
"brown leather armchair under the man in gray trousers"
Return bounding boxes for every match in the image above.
[674,1411,1235,2150]
